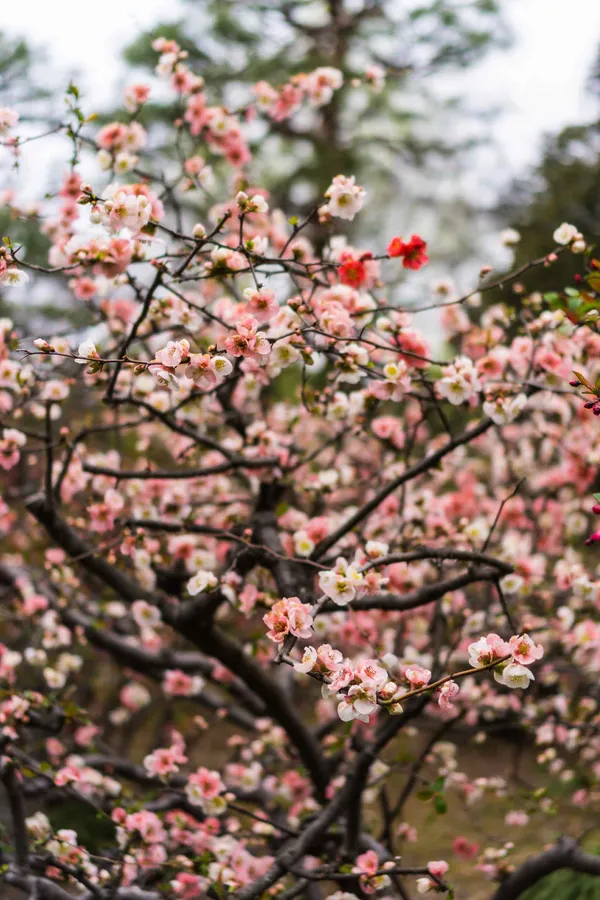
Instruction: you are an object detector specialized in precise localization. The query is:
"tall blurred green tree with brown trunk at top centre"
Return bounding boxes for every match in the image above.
[117,0,509,258]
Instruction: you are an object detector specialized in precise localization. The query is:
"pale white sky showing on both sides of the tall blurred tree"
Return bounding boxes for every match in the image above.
[2,0,600,175]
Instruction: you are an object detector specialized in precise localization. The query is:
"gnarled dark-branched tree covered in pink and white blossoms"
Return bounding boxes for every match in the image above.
[0,31,600,900]
